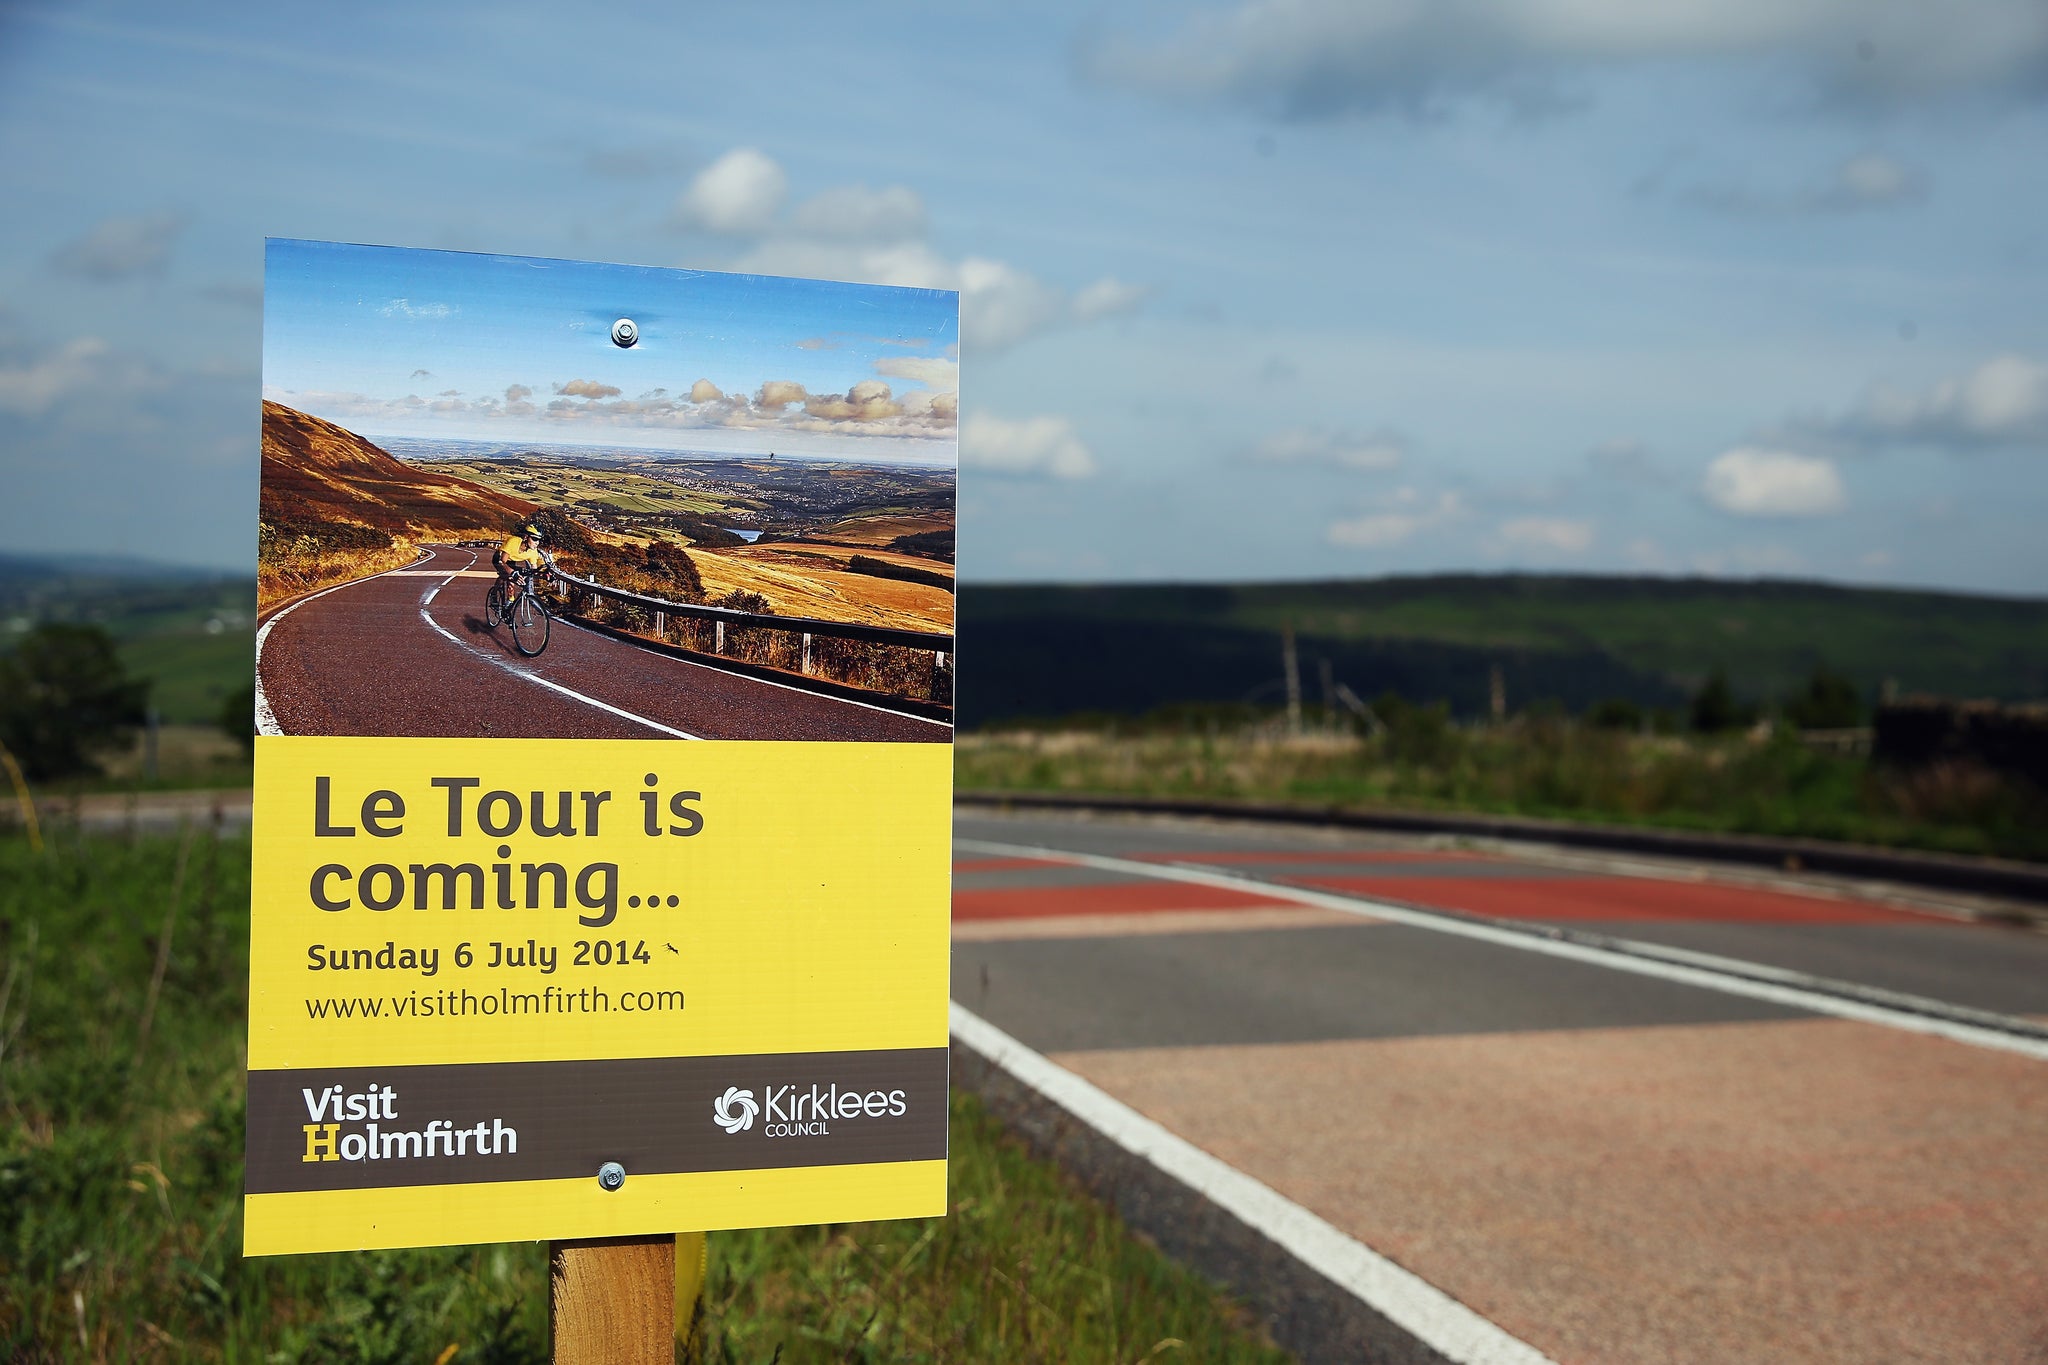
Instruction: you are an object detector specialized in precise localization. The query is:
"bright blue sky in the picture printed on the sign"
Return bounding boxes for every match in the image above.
[262,239,961,465]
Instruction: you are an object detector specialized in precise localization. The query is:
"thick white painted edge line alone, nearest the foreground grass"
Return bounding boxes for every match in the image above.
[950,1003,1552,1365]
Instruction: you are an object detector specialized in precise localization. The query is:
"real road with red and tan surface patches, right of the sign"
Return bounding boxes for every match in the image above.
[954,812,2048,1363]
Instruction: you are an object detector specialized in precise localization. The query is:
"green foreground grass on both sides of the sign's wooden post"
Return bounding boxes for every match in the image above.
[0,831,1284,1365]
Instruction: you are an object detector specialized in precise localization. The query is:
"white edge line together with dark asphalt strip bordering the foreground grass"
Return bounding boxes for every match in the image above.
[950,1003,1550,1365]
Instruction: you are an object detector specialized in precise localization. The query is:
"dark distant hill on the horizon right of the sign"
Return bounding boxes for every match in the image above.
[958,573,2048,726]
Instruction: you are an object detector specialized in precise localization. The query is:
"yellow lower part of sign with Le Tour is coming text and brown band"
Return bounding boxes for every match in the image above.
[248,737,952,1254]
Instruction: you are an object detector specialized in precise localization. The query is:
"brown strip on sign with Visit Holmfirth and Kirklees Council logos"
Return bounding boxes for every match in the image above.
[246,1048,946,1195]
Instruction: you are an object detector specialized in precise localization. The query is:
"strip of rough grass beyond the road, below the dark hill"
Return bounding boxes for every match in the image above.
[954,710,2048,860]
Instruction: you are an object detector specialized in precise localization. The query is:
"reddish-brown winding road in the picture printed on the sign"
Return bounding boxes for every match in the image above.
[256,544,952,743]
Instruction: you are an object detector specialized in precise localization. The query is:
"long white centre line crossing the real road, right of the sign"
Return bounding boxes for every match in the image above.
[954,839,2048,1062]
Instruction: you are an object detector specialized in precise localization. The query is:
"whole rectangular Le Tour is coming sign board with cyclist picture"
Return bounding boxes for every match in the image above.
[246,239,958,1254]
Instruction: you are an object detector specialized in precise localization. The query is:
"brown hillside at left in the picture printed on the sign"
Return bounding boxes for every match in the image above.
[262,401,535,536]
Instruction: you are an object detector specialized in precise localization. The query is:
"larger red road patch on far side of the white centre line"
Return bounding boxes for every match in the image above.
[1288,876,1925,925]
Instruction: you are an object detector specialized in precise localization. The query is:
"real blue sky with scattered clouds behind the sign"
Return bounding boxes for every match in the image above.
[0,0,2048,596]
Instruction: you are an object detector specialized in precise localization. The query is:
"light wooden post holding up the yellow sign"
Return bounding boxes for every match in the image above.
[547,1234,676,1365]
